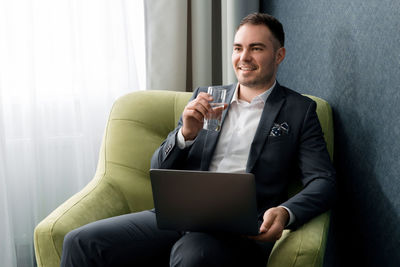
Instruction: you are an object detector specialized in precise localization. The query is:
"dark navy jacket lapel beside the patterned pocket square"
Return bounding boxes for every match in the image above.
[246,82,285,172]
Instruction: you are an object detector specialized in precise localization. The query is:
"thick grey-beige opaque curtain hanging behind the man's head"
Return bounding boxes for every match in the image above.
[145,0,260,91]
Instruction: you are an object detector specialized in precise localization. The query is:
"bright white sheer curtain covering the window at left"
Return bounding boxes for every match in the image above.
[0,0,146,266]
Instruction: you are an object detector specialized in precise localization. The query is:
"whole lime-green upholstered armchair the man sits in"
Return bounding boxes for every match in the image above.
[34,91,333,267]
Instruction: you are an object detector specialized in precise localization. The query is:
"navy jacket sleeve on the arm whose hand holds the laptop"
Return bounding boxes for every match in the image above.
[282,101,336,228]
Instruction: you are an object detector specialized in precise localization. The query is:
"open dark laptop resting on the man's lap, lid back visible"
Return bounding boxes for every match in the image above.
[150,169,259,235]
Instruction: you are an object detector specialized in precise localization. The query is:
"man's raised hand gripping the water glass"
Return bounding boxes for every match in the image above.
[182,92,212,141]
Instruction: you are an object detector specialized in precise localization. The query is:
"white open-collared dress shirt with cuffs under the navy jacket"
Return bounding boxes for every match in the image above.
[177,81,294,225]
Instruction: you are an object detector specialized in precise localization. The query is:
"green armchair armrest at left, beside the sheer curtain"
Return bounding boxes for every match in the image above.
[34,173,130,267]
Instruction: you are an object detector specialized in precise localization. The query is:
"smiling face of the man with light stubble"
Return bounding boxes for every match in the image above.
[232,24,285,89]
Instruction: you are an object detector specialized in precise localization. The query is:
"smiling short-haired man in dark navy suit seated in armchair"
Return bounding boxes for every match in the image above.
[61,14,335,266]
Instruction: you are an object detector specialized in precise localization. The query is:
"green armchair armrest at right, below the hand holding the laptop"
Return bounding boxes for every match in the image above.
[267,212,330,267]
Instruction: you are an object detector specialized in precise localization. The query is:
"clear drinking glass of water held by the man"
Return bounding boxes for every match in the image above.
[203,86,226,131]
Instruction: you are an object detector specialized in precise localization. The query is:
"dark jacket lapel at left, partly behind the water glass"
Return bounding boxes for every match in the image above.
[201,84,236,171]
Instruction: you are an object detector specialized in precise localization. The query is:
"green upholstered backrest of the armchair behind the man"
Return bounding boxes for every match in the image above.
[97,91,333,212]
